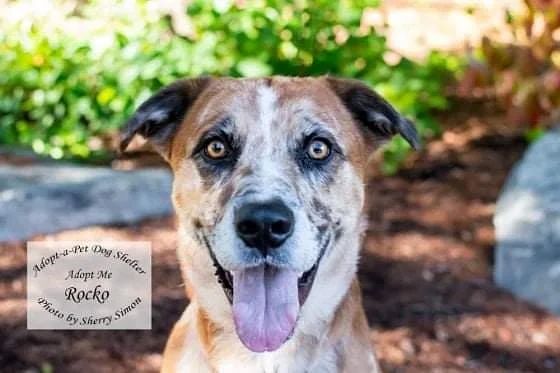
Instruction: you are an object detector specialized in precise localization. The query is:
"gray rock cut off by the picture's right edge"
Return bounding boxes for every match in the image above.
[494,129,560,315]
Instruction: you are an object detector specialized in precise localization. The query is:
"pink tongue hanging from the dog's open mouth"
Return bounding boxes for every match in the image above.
[233,265,299,352]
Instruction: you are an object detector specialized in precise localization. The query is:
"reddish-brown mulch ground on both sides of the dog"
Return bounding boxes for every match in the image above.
[0,103,560,373]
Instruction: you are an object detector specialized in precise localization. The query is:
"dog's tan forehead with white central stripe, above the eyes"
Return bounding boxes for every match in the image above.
[173,77,364,166]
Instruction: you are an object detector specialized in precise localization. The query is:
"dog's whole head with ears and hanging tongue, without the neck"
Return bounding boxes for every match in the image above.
[122,78,417,352]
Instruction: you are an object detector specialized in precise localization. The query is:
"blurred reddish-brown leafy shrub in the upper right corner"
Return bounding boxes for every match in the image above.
[459,0,560,130]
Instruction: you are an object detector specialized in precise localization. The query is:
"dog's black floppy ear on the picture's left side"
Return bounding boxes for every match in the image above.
[119,77,211,159]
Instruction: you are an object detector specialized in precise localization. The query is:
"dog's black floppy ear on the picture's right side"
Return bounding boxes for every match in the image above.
[327,77,420,150]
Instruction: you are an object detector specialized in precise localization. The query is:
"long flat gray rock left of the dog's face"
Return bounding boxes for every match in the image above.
[0,164,172,241]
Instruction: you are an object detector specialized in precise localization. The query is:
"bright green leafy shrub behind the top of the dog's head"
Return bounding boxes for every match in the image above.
[0,0,457,172]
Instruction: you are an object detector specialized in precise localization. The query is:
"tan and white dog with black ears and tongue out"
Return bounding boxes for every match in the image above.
[120,76,419,373]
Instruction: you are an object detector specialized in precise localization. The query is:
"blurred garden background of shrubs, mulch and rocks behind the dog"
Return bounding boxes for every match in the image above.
[0,0,560,372]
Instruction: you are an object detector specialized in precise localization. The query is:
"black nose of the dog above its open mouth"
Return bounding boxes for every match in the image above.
[235,200,294,253]
